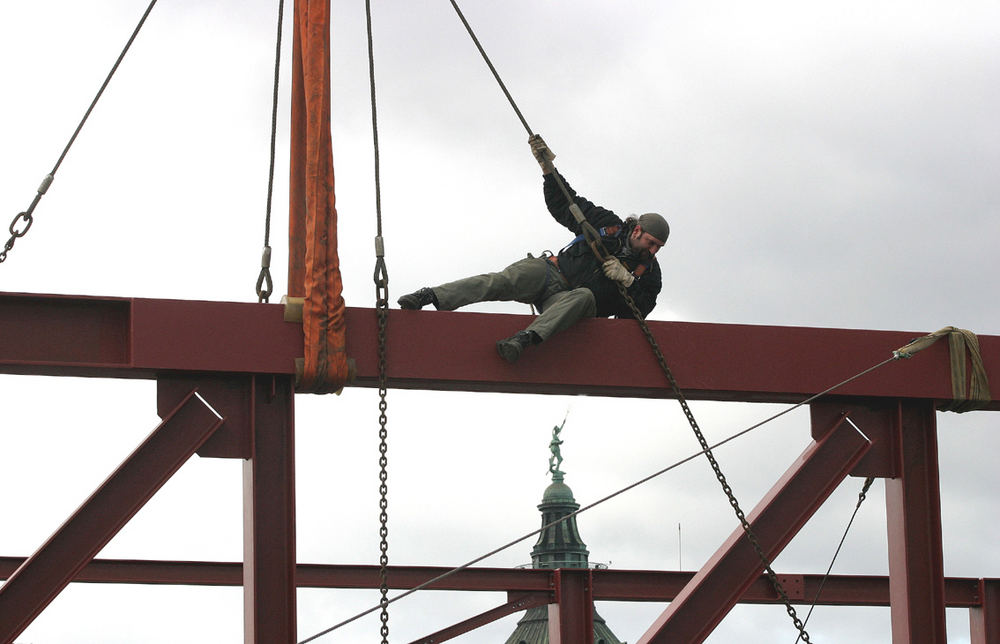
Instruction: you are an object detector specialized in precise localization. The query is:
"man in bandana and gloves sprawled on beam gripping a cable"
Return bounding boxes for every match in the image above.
[398,134,670,362]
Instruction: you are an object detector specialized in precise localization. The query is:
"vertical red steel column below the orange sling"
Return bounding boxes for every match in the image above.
[243,376,296,644]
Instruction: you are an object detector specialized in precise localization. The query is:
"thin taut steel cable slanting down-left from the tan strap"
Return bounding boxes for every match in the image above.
[298,357,899,644]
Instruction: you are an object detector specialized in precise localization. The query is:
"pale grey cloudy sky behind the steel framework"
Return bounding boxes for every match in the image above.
[0,0,1000,644]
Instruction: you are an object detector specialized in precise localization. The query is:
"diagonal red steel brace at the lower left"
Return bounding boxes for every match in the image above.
[0,391,222,643]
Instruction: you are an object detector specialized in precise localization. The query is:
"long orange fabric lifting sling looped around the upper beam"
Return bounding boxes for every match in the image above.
[288,0,348,393]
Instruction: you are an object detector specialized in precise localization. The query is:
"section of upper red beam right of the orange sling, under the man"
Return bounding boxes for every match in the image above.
[348,308,1000,410]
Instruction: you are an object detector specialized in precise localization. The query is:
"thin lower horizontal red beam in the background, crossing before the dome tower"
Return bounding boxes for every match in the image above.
[0,557,984,608]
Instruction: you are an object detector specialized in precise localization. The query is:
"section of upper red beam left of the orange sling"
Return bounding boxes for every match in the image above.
[0,293,302,379]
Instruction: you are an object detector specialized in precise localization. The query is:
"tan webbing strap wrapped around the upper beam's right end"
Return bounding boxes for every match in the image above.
[892,326,992,413]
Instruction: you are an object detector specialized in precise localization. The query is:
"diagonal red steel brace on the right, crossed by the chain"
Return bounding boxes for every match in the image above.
[639,422,871,644]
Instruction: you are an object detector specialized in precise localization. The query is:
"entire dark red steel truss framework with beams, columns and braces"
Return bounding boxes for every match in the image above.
[0,293,1000,644]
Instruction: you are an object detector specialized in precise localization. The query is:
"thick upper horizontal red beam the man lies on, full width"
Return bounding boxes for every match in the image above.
[0,293,1000,410]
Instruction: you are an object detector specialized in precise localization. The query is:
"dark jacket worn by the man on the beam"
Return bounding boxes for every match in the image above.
[543,174,662,318]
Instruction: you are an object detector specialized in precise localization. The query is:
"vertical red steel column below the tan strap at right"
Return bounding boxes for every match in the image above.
[885,400,947,644]
